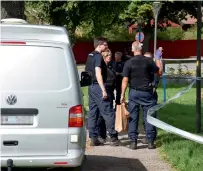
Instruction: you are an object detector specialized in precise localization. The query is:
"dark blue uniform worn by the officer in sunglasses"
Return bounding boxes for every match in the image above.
[86,51,117,138]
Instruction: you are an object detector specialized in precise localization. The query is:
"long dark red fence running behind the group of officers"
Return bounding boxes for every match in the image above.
[73,40,203,64]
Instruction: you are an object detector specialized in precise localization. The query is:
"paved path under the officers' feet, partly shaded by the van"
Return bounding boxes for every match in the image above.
[82,135,171,171]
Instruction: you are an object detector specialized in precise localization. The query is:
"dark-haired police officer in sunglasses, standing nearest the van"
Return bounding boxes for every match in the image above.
[86,37,119,146]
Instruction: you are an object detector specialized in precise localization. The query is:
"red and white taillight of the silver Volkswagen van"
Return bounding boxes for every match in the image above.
[68,105,83,127]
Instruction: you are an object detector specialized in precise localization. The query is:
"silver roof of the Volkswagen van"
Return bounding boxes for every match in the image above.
[0,23,70,44]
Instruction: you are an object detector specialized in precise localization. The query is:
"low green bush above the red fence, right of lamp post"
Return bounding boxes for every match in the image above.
[157,27,184,41]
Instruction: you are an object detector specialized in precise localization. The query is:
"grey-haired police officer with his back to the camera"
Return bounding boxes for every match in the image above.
[121,42,162,149]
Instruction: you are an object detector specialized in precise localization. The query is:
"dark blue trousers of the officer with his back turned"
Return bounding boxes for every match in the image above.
[128,88,157,142]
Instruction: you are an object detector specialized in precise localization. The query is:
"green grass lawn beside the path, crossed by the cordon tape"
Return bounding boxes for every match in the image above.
[82,85,203,171]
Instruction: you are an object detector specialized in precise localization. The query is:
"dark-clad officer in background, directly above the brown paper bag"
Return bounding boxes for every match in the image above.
[115,52,124,105]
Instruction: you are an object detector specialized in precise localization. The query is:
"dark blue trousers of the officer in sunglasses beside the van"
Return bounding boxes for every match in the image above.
[88,84,117,138]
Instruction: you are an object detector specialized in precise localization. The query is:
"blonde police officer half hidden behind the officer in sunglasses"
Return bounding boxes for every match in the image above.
[96,49,116,143]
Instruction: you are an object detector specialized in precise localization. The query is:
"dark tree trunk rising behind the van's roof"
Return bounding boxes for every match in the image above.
[1,1,25,19]
